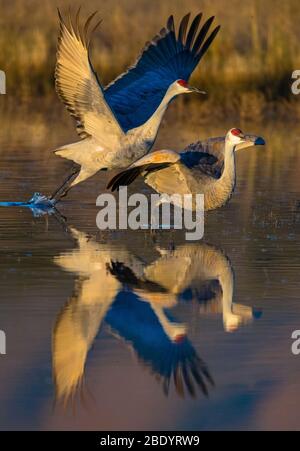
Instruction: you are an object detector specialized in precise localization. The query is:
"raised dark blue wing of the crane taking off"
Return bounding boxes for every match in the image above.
[105,13,220,130]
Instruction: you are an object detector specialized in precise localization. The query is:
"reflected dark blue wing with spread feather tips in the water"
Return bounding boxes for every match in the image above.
[105,292,214,397]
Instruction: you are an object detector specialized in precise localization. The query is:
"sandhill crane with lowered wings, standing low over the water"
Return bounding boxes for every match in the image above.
[108,128,265,210]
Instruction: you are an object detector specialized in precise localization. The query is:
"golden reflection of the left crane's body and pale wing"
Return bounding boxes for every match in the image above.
[53,228,124,399]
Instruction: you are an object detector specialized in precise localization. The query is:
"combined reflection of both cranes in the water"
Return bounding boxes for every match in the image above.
[53,228,253,402]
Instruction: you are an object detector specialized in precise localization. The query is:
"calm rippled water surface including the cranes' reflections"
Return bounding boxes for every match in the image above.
[0,104,300,430]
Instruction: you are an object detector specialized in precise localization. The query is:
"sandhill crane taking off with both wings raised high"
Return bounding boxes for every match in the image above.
[51,11,220,201]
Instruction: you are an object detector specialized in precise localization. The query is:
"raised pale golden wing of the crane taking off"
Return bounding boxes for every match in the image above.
[55,11,124,140]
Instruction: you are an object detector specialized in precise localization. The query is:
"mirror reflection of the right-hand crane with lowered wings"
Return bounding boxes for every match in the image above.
[142,243,254,332]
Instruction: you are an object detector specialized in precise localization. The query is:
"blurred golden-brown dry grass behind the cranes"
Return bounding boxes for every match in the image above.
[0,0,300,119]
